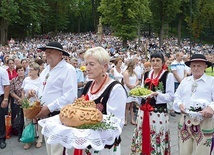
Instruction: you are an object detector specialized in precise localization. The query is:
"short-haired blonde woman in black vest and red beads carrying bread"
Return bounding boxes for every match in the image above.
[69,47,127,155]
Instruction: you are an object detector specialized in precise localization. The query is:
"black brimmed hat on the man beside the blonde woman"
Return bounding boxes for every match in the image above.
[38,42,70,56]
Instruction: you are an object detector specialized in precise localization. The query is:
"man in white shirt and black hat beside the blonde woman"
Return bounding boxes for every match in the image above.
[29,42,77,155]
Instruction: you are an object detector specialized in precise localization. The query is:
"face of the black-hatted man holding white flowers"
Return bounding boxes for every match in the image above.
[190,61,207,79]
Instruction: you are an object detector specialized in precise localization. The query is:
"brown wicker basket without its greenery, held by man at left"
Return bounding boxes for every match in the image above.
[23,106,42,119]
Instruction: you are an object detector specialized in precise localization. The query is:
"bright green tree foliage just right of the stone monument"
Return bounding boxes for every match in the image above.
[98,0,151,45]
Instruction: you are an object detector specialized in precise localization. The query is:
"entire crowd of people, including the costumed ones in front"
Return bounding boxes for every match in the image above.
[0,33,214,155]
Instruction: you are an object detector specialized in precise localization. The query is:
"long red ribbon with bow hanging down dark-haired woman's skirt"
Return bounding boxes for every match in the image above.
[140,98,154,155]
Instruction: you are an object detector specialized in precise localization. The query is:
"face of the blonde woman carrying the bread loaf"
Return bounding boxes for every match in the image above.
[85,56,106,79]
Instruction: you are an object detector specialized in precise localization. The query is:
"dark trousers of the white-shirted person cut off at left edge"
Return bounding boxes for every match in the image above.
[0,95,6,142]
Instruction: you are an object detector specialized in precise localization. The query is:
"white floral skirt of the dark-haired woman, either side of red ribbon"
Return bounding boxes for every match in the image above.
[130,110,170,155]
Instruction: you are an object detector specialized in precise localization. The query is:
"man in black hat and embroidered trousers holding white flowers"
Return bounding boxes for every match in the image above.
[174,54,214,155]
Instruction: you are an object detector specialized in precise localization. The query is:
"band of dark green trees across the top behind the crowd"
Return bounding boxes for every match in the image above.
[0,0,214,46]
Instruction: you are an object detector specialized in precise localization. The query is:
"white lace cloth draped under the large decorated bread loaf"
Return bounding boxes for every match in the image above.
[39,115,122,150]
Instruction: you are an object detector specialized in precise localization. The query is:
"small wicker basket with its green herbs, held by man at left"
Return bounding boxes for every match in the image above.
[21,98,42,119]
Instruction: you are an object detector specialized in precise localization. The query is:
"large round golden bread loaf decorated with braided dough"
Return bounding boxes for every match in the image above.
[59,98,103,127]
